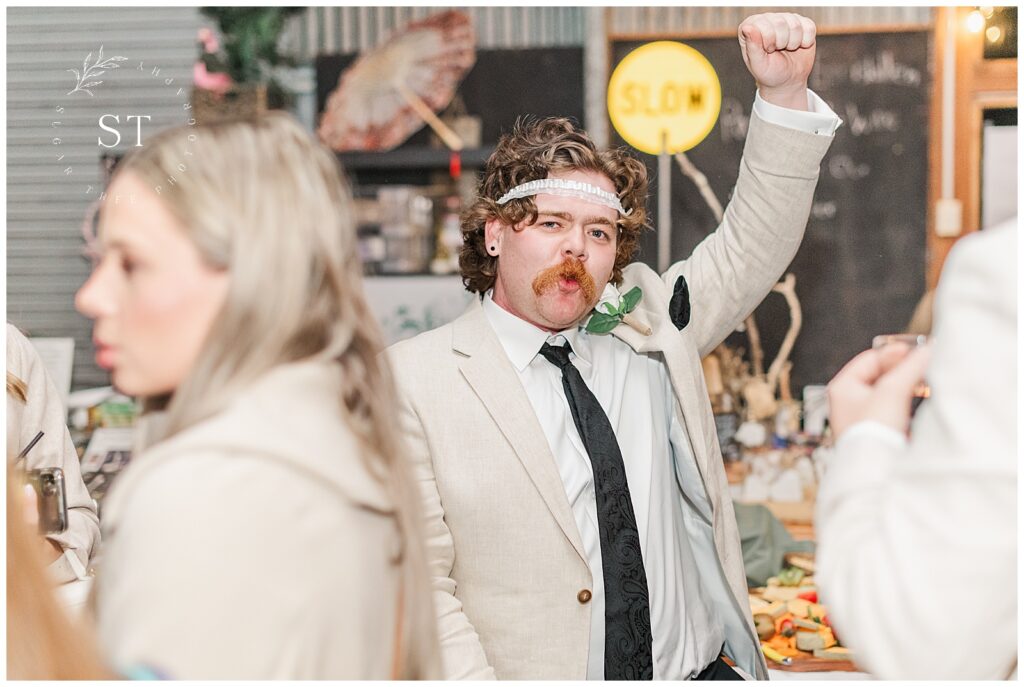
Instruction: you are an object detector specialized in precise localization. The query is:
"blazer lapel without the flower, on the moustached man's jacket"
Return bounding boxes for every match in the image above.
[452,299,587,562]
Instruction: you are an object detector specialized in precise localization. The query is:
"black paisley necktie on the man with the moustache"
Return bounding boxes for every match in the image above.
[541,343,654,680]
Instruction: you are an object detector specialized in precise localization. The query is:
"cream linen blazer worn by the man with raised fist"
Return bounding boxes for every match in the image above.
[389,116,831,680]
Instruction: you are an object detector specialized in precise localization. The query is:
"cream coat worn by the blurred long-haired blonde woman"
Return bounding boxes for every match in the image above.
[95,362,399,680]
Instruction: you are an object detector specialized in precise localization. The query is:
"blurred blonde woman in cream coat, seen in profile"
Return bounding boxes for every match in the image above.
[77,114,439,679]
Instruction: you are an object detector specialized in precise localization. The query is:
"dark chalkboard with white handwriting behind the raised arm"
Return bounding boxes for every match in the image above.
[611,30,932,394]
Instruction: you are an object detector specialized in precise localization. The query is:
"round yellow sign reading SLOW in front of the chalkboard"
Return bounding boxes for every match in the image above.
[608,41,722,155]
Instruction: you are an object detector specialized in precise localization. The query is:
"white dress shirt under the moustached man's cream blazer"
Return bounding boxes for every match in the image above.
[483,90,842,680]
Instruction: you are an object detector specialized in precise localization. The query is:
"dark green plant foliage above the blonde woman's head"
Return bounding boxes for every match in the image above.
[200,7,306,108]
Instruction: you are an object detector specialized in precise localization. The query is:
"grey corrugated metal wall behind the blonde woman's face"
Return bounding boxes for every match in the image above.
[7,7,200,388]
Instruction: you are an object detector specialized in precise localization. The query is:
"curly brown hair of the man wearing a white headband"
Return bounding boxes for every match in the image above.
[459,117,649,294]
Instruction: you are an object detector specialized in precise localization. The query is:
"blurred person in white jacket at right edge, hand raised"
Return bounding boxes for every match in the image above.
[815,219,1017,680]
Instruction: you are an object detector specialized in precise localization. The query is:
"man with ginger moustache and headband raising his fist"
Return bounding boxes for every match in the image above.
[389,14,840,679]
